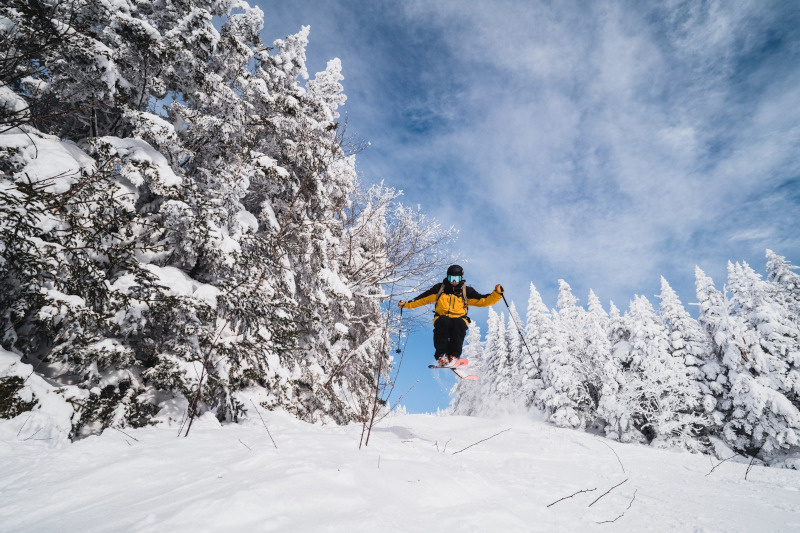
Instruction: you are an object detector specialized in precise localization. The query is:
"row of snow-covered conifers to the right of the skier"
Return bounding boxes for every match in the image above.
[452,250,800,468]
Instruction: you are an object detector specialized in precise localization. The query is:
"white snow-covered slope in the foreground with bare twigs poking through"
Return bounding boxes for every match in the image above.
[0,410,800,532]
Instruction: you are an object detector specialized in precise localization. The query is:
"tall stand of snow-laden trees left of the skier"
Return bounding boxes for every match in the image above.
[0,0,453,435]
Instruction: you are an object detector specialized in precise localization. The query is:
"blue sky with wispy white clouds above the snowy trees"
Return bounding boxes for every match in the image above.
[252,0,800,412]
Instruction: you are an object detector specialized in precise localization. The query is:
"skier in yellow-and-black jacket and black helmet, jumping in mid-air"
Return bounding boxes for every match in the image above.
[397,265,503,366]
